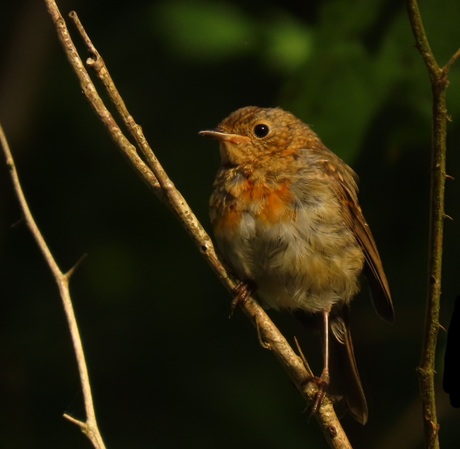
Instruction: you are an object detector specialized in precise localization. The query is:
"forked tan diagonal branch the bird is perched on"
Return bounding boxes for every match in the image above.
[45,0,351,449]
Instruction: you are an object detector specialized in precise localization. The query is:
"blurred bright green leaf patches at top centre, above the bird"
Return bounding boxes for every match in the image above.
[151,0,311,73]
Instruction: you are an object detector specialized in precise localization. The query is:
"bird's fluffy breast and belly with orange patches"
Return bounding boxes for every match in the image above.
[210,165,364,311]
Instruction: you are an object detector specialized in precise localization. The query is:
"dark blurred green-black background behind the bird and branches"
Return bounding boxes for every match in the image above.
[0,0,460,449]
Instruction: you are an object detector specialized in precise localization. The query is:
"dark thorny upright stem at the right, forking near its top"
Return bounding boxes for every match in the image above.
[406,0,460,449]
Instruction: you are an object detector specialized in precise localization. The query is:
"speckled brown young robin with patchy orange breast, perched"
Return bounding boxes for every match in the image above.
[200,106,393,424]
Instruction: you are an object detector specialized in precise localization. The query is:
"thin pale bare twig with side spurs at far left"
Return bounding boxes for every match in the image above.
[0,124,105,449]
